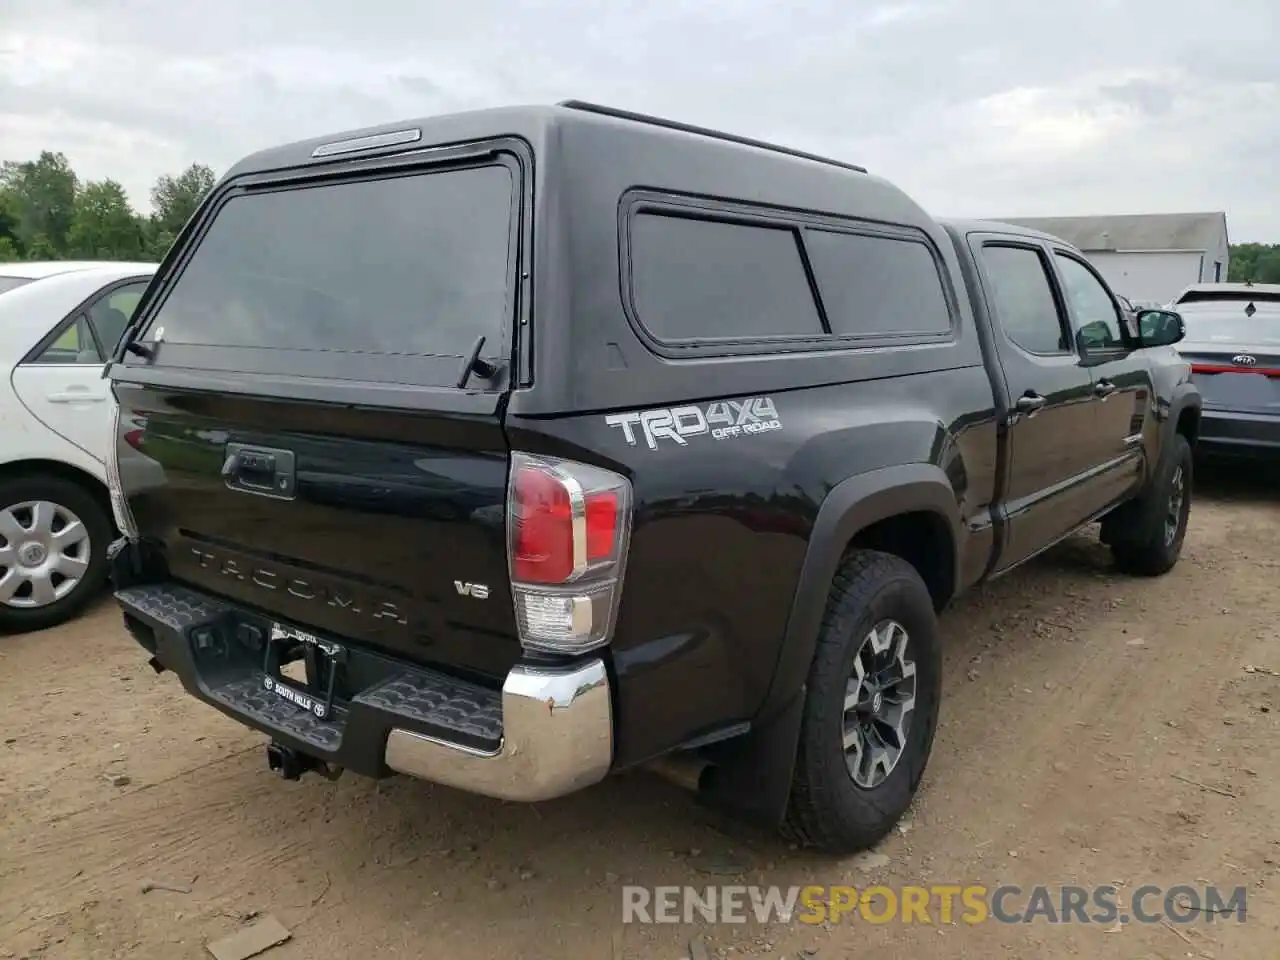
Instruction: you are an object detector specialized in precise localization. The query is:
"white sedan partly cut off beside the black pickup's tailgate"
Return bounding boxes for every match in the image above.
[0,261,156,632]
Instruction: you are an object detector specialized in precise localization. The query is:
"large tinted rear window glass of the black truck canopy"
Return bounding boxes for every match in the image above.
[145,166,512,366]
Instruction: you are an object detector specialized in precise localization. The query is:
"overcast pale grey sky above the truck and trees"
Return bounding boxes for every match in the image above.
[0,0,1280,242]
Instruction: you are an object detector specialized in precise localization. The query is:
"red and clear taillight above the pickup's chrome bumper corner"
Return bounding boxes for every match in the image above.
[507,453,631,653]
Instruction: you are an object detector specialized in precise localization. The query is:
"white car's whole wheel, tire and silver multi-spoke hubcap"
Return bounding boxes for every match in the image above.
[0,474,111,632]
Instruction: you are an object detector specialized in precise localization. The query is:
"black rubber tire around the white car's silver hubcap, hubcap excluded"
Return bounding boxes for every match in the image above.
[0,474,115,634]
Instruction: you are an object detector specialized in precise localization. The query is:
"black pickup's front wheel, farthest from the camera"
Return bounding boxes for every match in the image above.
[1107,434,1193,577]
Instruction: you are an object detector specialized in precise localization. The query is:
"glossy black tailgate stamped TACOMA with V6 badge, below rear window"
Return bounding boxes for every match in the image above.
[116,383,520,676]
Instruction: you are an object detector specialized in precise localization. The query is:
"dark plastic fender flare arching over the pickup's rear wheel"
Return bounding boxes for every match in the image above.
[758,463,961,721]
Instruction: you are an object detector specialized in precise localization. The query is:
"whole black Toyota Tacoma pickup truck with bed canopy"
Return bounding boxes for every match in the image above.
[108,101,1201,852]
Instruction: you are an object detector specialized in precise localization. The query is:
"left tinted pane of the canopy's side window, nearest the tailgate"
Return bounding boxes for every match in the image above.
[631,214,823,340]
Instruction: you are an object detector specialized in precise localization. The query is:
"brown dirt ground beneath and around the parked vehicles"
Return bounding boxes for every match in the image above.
[0,471,1280,960]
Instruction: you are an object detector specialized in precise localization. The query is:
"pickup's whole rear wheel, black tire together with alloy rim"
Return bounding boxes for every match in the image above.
[783,550,942,854]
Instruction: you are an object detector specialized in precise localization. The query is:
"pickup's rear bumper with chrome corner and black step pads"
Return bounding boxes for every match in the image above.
[115,578,613,801]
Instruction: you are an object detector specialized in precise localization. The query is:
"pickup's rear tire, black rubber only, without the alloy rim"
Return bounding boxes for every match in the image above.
[782,550,942,855]
